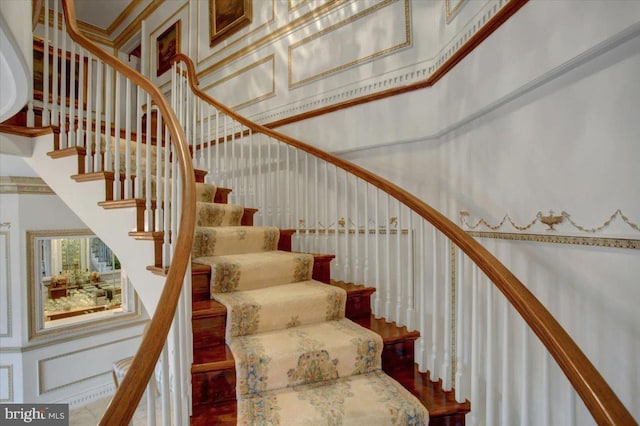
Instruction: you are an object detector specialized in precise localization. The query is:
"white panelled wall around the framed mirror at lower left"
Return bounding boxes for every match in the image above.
[0,155,143,407]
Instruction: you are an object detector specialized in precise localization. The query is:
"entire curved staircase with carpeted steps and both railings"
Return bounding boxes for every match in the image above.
[6,0,635,425]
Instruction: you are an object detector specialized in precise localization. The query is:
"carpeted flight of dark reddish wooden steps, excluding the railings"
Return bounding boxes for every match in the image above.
[185,184,469,425]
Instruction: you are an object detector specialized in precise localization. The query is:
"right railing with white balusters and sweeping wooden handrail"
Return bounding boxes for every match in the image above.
[171,55,635,425]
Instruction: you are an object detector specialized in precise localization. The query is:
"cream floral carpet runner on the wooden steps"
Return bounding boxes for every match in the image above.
[192,184,429,425]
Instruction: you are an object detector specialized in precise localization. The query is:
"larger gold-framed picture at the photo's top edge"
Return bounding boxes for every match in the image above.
[209,0,253,47]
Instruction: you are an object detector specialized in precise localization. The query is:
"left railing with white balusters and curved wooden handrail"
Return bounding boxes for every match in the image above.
[27,0,195,425]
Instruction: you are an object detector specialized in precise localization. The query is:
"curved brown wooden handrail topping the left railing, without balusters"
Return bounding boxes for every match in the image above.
[62,0,195,426]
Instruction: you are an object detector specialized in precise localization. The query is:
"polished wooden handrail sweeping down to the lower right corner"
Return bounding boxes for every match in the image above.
[174,54,637,425]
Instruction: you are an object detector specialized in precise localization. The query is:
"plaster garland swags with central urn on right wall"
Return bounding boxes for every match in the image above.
[458,209,640,234]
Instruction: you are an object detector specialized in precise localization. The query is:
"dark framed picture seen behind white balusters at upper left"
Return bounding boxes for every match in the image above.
[33,38,89,108]
